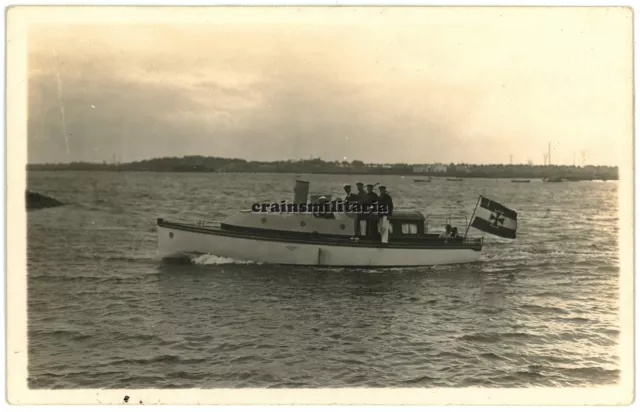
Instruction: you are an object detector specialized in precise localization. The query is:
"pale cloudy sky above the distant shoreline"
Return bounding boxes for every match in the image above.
[27,7,633,165]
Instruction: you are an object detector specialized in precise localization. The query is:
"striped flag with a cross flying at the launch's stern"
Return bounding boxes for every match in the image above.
[471,196,518,239]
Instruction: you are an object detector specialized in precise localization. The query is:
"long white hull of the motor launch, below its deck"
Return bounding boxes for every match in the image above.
[157,225,481,267]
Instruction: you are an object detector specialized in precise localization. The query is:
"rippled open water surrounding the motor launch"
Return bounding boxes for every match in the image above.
[28,172,620,388]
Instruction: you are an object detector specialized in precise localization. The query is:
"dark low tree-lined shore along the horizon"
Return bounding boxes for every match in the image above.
[27,156,618,180]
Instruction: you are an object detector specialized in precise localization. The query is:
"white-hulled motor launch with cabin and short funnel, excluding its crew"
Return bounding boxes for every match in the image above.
[157,180,515,267]
